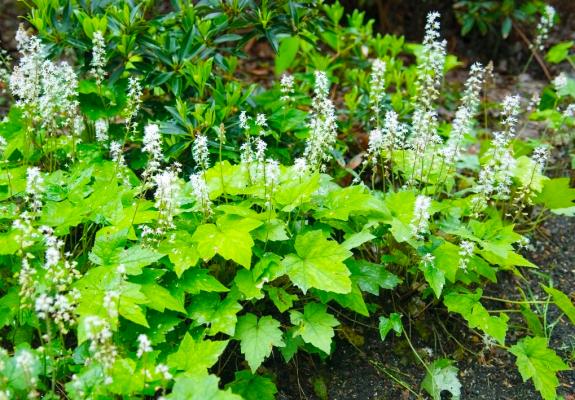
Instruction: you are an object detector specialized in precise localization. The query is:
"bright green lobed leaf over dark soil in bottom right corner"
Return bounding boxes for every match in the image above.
[509,337,569,400]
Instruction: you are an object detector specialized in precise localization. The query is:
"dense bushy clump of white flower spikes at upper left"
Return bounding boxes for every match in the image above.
[9,27,79,130]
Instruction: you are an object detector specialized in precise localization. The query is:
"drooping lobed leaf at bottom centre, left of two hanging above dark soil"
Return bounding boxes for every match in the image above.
[235,314,285,373]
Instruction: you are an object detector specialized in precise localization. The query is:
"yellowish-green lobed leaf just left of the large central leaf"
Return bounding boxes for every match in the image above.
[192,215,262,269]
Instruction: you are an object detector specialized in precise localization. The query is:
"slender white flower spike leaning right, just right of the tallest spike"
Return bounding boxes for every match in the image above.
[441,63,485,165]
